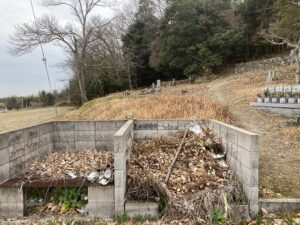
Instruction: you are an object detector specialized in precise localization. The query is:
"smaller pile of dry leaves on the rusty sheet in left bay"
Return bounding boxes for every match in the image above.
[27,150,114,179]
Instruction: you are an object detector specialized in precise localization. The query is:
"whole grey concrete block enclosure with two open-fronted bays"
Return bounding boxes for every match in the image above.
[0,120,259,218]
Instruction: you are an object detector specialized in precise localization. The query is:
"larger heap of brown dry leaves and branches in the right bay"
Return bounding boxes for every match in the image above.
[127,127,246,222]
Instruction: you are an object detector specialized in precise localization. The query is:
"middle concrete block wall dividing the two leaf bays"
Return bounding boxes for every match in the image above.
[114,120,134,215]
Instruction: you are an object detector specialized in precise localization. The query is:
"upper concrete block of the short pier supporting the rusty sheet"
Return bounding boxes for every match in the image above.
[88,185,115,203]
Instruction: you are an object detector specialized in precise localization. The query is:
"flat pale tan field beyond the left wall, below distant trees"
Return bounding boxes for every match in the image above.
[0,107,73,132]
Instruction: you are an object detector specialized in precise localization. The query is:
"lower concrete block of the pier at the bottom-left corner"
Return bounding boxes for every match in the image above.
[0,203,24,219]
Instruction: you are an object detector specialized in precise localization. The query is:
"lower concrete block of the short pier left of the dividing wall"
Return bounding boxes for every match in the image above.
[87,203,115,219]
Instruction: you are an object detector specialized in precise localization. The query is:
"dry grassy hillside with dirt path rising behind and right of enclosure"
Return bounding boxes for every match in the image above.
[64,66,300,197]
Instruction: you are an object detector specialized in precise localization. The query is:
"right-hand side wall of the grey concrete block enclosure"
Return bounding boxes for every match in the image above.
[209,120,259,215]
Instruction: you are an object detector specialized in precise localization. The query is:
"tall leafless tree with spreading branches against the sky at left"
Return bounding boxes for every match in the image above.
[10,0,111,103]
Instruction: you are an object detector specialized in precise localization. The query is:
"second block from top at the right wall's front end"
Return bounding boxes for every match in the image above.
[238,146,259,169]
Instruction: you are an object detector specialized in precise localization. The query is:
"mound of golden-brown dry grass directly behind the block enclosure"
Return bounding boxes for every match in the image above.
[64,89,230,122]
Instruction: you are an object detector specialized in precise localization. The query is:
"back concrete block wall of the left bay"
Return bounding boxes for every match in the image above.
[53,120,126,151]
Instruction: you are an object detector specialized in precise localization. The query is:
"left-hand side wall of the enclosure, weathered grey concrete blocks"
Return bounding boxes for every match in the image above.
[0,123,53,183]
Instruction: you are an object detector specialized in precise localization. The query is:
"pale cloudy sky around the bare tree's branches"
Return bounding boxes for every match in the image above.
[0,0,120,97]
